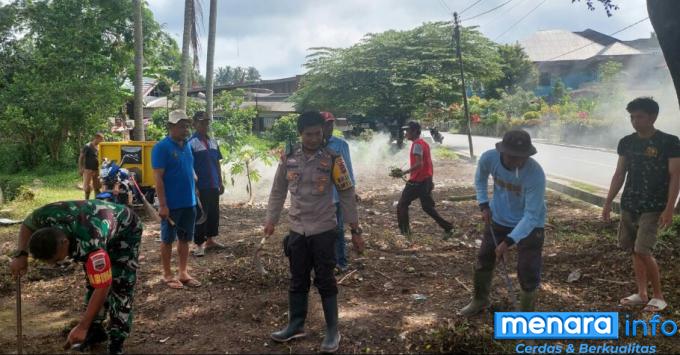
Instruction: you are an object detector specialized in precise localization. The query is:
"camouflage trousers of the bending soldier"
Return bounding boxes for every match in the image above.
[85,215,142,342]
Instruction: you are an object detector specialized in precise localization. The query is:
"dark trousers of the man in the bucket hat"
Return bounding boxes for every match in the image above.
[476,223,545,292]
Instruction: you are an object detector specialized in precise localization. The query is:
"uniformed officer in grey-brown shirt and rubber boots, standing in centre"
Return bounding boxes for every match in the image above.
[264,111,360,352]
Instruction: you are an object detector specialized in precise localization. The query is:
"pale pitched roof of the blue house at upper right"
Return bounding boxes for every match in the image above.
[520,29,642,62]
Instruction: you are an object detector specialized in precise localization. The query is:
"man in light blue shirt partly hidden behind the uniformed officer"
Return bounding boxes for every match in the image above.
[321,112,363,272]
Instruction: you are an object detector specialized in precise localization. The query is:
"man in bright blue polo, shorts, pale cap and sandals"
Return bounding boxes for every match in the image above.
[151,110,201,289]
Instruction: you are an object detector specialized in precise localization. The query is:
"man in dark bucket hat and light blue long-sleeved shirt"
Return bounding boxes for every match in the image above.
[460,130,546,316]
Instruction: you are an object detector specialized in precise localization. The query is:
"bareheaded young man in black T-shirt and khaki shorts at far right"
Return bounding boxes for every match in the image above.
[602,97,680,312]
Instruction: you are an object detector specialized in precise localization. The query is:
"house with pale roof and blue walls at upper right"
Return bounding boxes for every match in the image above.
[519,29,665,96]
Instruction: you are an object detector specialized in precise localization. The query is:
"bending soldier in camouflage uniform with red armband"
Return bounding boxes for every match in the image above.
[11,200,142,354]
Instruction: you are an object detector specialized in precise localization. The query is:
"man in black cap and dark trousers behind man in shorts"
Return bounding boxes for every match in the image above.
[189,111,224,256]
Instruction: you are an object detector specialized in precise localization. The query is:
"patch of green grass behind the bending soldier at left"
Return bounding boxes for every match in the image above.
[0,169,83,219]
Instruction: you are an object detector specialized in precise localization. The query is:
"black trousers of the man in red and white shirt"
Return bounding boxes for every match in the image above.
[397,178,453,233]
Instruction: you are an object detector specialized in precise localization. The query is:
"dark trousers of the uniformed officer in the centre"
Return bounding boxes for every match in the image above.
[283,229,338,297]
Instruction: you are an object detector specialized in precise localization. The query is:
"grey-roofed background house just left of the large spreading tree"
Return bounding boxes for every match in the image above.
[188,75,302,132]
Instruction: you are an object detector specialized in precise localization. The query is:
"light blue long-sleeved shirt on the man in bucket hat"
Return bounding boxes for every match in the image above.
[475,149,546,243]
